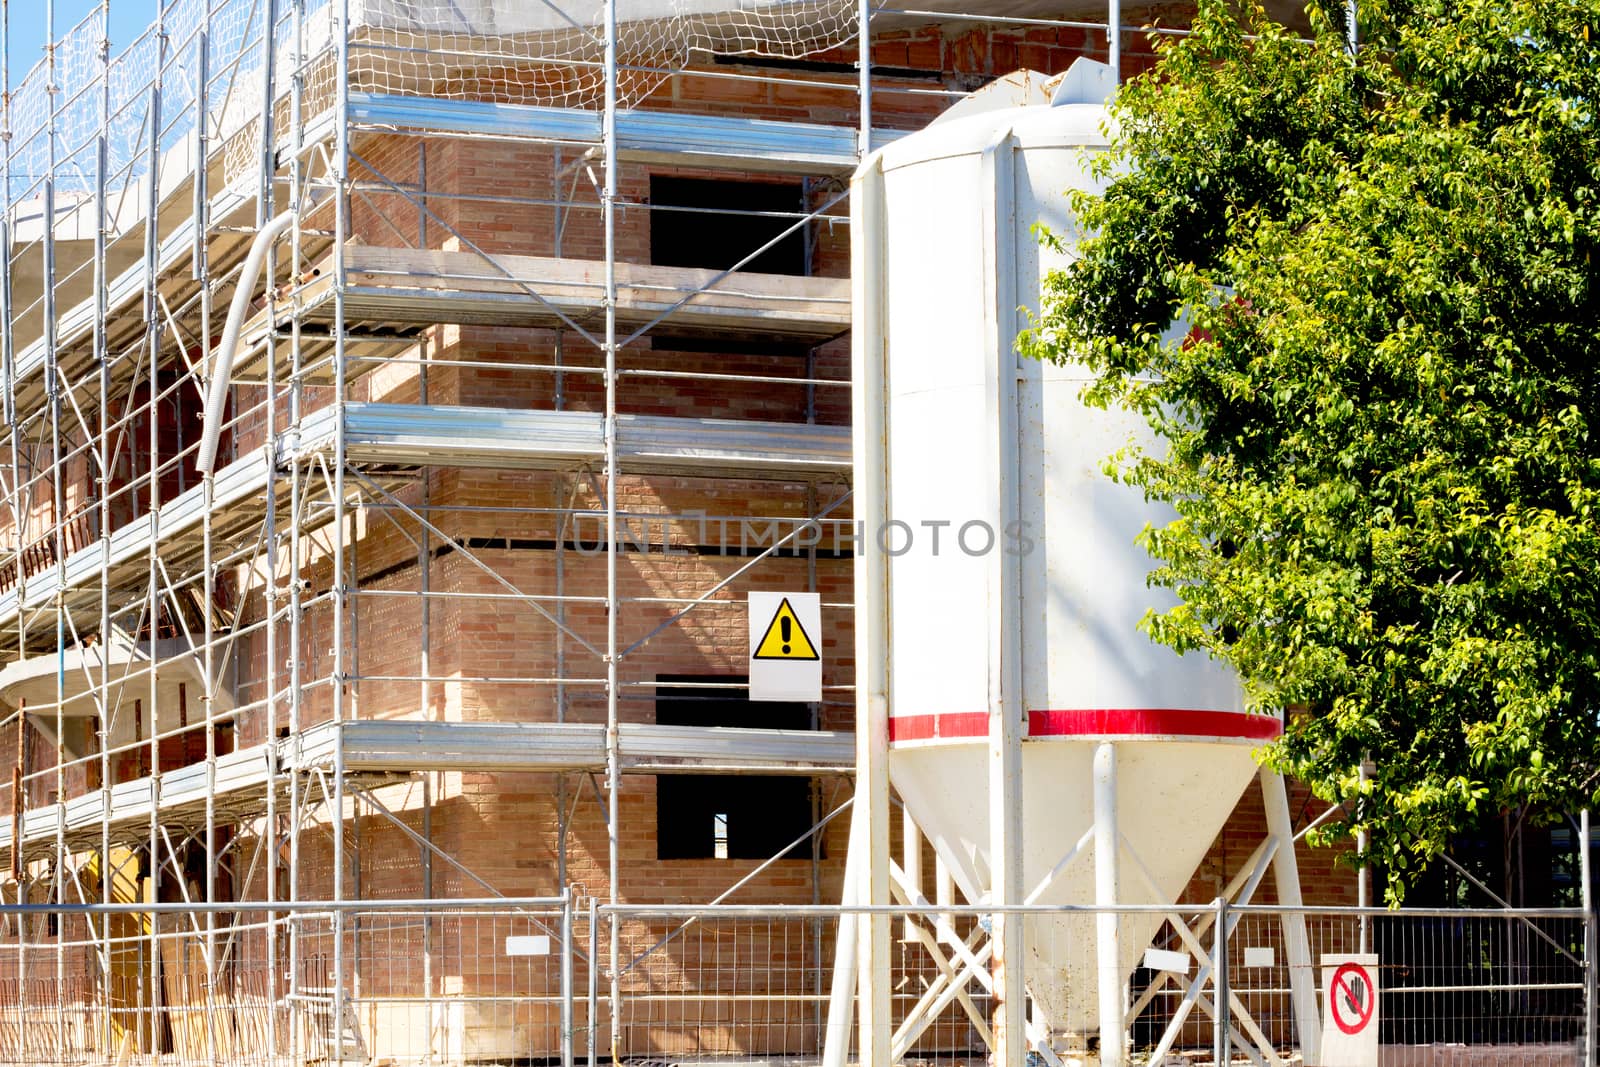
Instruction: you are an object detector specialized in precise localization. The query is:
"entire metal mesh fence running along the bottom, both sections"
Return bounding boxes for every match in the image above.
[0,899,1589,1067]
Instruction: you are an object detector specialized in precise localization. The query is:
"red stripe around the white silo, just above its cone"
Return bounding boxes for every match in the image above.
[890,707,1283,742]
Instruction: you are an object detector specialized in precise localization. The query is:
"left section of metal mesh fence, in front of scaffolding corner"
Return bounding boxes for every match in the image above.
[0,901,573,1067]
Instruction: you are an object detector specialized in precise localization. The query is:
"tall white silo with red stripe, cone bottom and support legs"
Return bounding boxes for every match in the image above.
[824,59,1320,1067]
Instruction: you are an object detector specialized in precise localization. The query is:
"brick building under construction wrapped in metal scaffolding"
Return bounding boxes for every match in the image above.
[0,0,1574,1064]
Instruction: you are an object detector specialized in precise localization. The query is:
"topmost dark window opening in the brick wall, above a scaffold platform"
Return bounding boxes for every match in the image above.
[650,174,810,277]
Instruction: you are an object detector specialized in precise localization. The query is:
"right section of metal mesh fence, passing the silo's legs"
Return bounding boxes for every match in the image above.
[590,907,1586,1067]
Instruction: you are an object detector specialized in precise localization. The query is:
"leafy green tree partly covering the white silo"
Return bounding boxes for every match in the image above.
[1021,0,1600,899]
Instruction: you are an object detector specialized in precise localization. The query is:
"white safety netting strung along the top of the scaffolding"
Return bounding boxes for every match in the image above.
[9,0,858,212]
